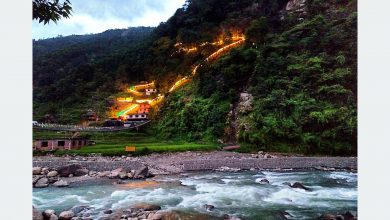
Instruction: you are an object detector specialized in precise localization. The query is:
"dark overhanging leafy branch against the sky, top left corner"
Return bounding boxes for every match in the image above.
[32,0,72,24]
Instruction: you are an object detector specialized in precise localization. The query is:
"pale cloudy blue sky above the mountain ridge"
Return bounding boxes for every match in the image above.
[32,0,185,39]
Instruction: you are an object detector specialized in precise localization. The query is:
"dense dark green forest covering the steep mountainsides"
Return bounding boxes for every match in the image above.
[33,0,357,155]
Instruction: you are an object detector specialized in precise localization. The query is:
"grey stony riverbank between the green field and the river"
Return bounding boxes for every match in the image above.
[33,151,357,178]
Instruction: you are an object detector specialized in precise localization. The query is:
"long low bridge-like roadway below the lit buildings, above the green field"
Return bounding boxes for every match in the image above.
[33,120,150,132]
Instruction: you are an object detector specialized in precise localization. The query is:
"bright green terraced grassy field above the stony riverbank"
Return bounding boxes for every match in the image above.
[33,130,218,156]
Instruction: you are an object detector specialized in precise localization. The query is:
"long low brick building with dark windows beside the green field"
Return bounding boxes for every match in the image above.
[33,138,90,151]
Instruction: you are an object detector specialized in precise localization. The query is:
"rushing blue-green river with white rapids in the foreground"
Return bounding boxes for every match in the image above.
[33,171,357,219]
